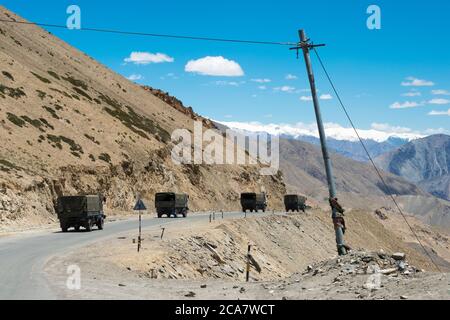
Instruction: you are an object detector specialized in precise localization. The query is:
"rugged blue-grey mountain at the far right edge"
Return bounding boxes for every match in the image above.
[376,134,450,200]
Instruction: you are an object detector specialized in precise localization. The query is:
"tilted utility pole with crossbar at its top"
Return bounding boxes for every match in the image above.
[291,30,347,255]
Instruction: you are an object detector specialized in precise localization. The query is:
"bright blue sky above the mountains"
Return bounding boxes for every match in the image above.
[2,0,450,133]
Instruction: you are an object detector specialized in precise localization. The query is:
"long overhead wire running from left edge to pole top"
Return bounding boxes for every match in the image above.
[0,19,296,46]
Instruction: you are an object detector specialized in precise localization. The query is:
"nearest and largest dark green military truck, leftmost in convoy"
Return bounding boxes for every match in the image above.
[55,195,106,232]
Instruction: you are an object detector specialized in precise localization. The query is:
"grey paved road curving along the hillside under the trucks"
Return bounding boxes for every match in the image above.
[0,213,243,300]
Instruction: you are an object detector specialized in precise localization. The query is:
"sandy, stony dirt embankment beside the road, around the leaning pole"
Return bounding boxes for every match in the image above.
[45,212,449,300]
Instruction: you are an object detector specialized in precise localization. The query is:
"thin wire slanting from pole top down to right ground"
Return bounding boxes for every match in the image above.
[313,48,443,273]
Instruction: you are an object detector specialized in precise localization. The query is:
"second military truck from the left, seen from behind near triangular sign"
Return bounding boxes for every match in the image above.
[155,192,189,218]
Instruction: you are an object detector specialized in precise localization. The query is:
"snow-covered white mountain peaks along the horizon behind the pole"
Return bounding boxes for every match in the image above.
[217,121,433,142]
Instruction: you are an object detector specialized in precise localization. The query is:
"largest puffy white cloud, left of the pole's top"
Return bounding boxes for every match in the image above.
[184,56,244,77]
